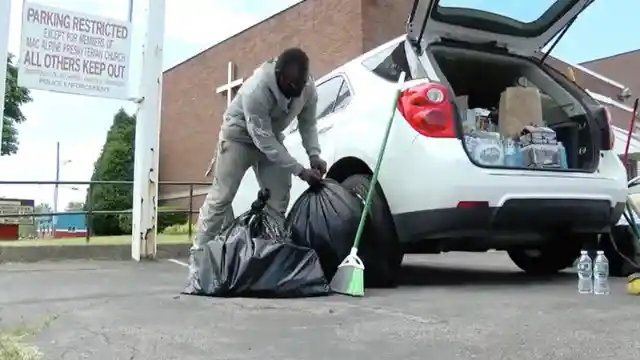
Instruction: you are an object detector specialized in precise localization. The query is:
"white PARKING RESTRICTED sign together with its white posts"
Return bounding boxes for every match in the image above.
[11,0,165,261]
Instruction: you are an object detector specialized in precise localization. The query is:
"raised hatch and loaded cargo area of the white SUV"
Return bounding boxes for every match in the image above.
[408,0,611,172]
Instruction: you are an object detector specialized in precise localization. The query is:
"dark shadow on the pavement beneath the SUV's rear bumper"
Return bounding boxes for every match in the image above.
[399,264,575,286]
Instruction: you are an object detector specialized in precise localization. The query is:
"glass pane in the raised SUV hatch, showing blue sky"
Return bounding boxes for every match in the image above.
[432,0,580,37]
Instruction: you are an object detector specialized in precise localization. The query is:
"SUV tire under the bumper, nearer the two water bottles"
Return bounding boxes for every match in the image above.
[507,239,581,275]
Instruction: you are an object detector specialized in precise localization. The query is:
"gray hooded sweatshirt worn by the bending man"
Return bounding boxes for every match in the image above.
[220,61,320,175]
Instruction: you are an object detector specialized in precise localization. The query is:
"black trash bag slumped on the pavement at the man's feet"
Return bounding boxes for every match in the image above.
[183,190,329,297]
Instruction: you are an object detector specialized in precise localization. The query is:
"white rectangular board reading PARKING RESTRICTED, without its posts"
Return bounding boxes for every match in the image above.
[18,0,132,100]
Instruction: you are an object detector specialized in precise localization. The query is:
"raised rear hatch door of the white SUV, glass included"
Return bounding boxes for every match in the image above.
[407,0,595,56]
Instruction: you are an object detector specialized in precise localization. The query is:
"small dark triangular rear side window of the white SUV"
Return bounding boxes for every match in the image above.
[362,41,427,82]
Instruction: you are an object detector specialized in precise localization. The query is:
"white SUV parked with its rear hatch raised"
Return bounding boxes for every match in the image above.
[234,0,627,278]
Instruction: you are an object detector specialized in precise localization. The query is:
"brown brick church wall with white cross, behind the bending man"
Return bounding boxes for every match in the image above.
[159,0,362,200]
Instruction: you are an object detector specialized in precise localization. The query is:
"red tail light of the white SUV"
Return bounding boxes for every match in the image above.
[398,83,456,138]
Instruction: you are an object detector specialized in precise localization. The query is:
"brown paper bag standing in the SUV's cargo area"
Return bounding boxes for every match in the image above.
[498,86,544,138]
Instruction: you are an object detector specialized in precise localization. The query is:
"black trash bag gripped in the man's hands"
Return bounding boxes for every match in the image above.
[285,179,362,280]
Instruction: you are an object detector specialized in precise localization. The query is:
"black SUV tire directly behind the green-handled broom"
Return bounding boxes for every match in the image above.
[341,175,403,287]
